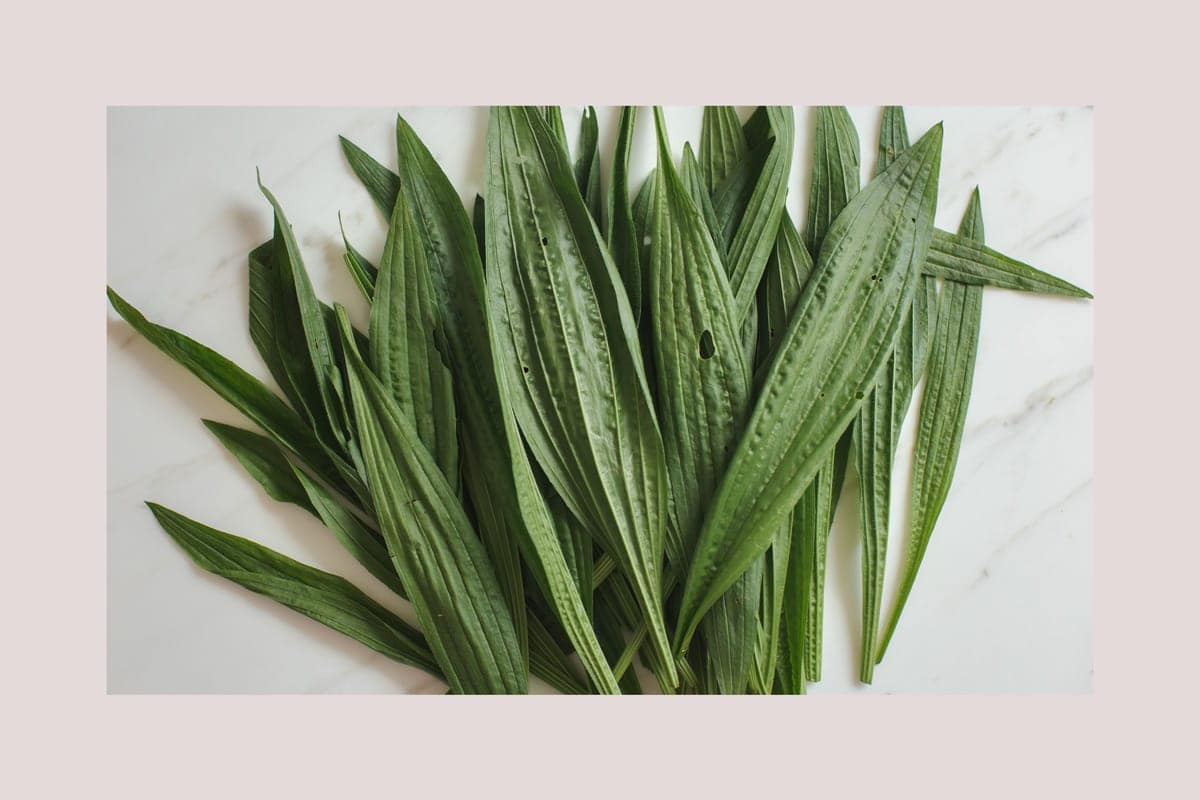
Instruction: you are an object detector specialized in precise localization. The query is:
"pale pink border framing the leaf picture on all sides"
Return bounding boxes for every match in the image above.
[7,0,1200,798]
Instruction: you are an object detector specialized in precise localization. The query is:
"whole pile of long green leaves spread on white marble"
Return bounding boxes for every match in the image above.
[108,107,1091,694]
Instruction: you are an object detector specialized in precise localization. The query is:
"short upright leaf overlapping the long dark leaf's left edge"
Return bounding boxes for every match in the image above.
[370,184,458,486]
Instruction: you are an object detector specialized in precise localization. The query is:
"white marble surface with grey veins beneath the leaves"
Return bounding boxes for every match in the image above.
[107,107,1096,693]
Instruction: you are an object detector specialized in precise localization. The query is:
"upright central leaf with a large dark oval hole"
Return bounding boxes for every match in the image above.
[650,108,762,693]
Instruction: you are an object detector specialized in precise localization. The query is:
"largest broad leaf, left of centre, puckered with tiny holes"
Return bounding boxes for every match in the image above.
[485,108,674,682]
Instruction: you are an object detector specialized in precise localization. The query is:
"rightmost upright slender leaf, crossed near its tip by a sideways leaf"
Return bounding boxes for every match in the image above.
[876,190,983,663]
